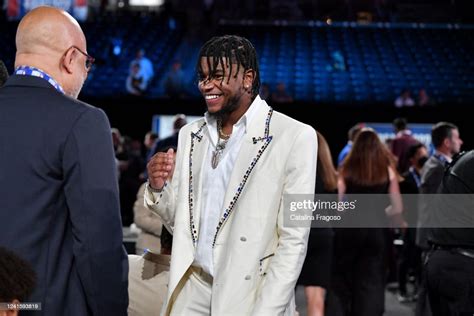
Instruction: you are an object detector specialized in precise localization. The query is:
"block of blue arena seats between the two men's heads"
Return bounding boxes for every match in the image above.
[82,14,182,96]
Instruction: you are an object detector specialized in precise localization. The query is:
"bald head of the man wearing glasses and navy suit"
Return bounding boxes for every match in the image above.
[15,6,88,98]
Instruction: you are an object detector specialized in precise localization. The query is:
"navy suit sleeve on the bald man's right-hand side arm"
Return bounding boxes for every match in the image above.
[63,109,128,315]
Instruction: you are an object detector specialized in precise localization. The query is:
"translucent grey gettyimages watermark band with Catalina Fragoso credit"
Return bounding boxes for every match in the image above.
[283,194,474,228]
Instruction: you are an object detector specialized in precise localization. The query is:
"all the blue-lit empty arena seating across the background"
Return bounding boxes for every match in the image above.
[0,13,474,105]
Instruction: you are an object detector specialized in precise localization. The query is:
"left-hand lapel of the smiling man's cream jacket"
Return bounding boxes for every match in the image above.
[188,122,209,247]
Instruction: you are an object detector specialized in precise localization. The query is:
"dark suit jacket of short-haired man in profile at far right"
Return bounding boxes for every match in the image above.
[416,156,445,249]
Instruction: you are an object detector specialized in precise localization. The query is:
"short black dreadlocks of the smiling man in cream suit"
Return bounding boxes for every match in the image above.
[196,35,260,98]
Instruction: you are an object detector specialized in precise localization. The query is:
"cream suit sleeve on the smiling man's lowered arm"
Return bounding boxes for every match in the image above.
[252,126,318,316]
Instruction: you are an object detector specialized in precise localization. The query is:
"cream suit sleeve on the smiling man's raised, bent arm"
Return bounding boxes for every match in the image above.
[144,128,185,233]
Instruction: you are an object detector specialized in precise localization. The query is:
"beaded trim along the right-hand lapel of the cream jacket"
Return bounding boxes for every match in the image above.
[212,108,273,248]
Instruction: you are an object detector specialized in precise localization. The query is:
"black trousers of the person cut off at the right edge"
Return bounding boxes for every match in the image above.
[426,250,474,316]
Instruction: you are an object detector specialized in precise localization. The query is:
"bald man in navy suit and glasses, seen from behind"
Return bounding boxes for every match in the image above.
[0,7,128,316]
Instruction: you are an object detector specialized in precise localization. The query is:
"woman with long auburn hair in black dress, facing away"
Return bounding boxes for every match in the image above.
[331,128,403,316]
